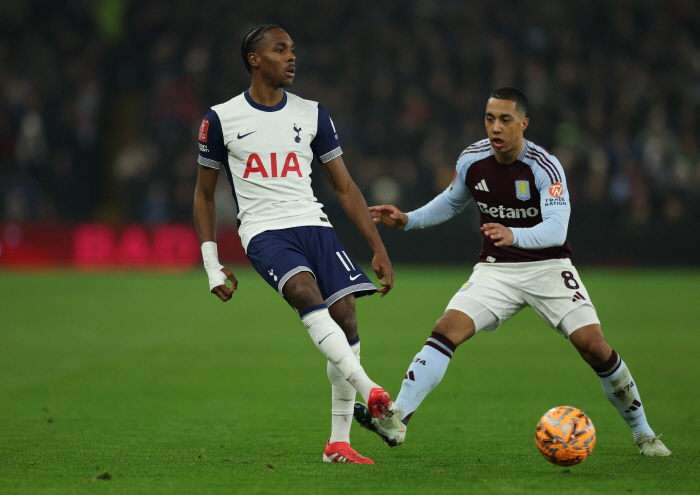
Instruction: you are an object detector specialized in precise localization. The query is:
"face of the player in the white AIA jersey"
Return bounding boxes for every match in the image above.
[251,29,296,88]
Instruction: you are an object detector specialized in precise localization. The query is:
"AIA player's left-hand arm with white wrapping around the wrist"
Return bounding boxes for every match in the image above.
[194,165,238,302]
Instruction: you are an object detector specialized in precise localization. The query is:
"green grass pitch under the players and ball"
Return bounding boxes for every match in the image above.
[0,266,700,495]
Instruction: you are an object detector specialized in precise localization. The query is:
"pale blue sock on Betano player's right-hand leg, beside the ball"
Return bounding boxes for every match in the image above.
[593,351,655,443]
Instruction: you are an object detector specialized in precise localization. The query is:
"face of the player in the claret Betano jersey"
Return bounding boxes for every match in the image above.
[486,98,530,163]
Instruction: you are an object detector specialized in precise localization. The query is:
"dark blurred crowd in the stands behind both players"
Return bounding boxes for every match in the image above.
[0,0,700,260]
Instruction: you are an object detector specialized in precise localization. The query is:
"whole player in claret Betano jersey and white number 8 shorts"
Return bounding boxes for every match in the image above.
[355,88,671,456]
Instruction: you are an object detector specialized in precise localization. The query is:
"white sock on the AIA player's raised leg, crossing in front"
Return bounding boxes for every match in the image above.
[299,304,379,402]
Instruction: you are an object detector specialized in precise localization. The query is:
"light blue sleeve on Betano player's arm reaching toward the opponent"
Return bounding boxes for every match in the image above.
[404,162,472,230]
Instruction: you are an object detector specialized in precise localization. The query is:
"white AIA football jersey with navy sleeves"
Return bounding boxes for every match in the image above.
[198,91,343,250]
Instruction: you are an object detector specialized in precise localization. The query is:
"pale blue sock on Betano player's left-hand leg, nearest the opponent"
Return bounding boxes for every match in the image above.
[396,332,456,424]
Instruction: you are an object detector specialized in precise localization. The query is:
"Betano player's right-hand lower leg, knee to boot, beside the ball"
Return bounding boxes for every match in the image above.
[570,323,671,456]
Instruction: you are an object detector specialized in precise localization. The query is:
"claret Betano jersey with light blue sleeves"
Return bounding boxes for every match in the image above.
[405,139,572,263]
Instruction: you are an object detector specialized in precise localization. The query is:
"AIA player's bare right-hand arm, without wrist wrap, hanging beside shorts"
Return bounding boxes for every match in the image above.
[323,156,394,297]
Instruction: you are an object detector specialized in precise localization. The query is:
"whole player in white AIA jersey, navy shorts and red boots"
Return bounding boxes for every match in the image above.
[194,24,401,464]
